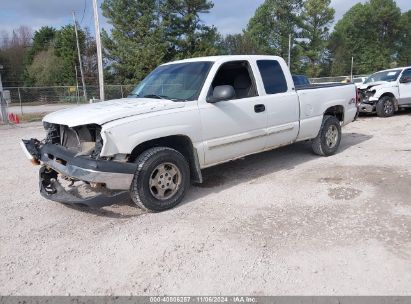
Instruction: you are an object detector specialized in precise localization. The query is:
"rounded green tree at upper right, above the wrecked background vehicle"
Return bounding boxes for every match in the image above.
[330,0,401,75]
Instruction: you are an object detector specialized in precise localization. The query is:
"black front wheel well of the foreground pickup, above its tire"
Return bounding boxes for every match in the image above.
[130,135,203,183]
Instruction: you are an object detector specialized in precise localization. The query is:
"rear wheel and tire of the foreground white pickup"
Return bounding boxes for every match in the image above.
[311,115,341,156]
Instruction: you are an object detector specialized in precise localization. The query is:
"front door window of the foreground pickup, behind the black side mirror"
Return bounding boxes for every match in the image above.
[209,61,258,99]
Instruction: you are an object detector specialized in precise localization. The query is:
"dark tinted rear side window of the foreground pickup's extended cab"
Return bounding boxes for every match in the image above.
[257,60,288,95]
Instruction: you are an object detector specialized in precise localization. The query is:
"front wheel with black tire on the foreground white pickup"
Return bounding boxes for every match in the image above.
[130,147,190,212]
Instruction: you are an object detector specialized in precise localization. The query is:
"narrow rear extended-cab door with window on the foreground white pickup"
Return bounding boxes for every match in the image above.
[256,59,300,149]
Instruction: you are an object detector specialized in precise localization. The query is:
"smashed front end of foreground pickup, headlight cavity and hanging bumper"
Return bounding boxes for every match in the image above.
[22,123,136,206]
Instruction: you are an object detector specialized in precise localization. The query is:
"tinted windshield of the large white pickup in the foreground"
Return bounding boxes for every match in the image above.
[129,62,213,101]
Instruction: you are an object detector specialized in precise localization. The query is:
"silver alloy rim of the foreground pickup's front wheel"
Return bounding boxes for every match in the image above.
[149,163,181,201]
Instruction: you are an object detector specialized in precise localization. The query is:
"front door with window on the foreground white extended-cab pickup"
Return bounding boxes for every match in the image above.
[199,60,267,166]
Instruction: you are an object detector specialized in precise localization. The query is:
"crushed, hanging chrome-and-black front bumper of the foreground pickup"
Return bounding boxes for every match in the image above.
[22,139,136,206]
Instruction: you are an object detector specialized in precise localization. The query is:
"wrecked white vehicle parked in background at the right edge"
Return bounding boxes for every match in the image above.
[359,67,411,117]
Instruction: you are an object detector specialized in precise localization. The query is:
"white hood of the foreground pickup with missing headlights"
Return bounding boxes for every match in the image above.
[43,98,184,127]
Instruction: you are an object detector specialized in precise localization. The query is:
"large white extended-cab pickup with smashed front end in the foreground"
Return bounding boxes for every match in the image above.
[22,56,357,211]
